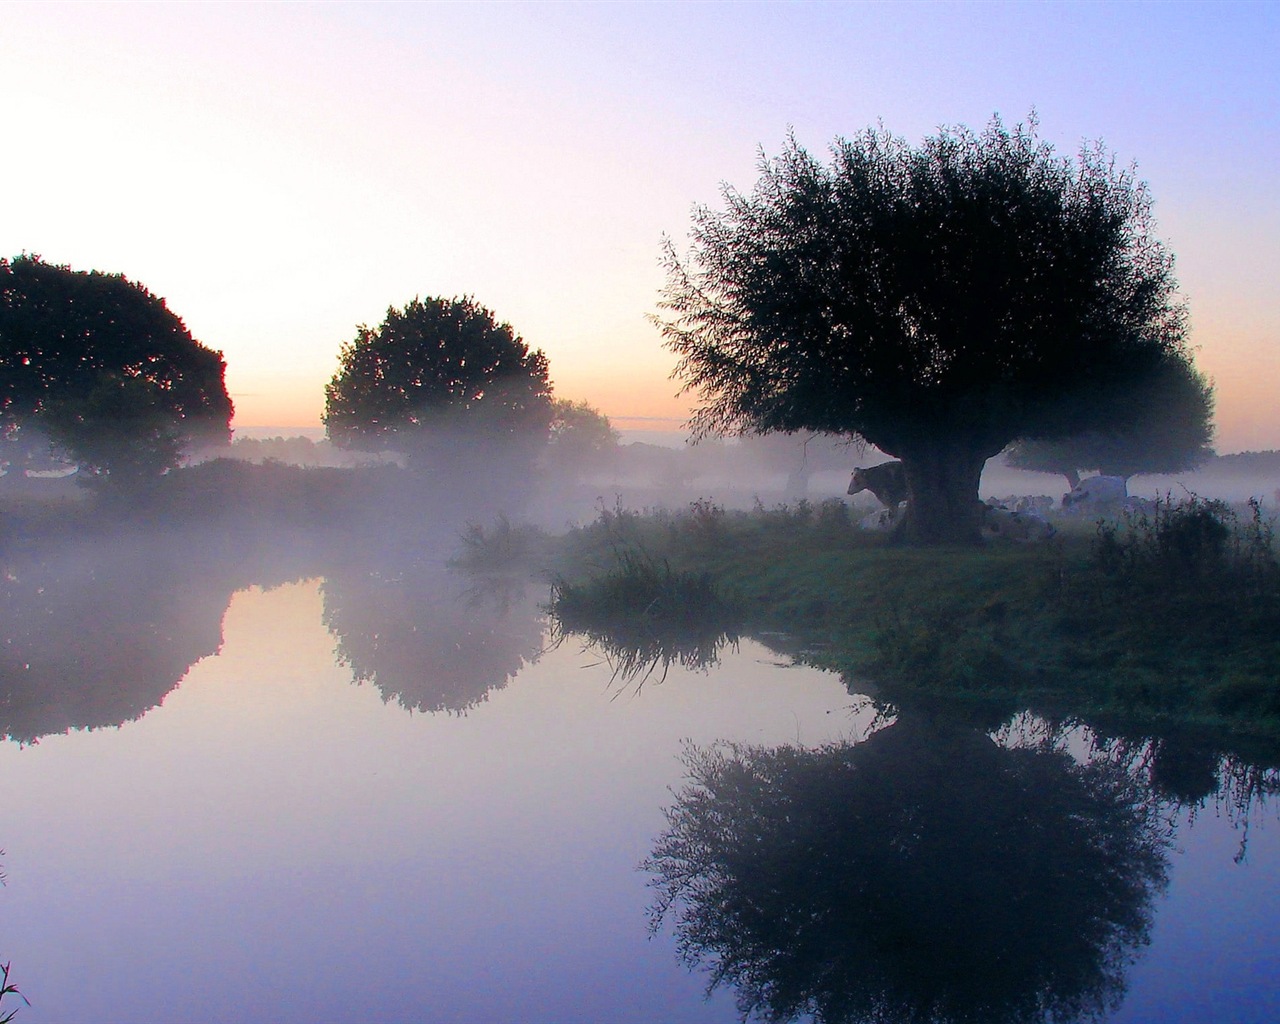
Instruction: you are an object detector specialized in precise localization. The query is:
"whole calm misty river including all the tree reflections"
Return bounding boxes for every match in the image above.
[0,540,1280,1024]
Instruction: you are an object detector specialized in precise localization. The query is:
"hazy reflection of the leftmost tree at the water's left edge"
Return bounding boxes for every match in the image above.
[0,535,244,742]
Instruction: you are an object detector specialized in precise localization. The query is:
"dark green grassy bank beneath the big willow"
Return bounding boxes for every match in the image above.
[532,500,1280,745]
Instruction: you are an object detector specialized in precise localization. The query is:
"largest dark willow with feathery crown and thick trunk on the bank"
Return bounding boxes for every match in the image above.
[658,119,1187,543]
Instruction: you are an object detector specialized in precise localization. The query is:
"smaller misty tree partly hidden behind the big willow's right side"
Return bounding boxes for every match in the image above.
[1006,356,1213,488]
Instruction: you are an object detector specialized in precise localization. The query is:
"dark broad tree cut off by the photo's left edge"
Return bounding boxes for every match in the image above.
[0,256,232,481]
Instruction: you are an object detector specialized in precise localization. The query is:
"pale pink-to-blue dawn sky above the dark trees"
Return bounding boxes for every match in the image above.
[0,3,1280,453]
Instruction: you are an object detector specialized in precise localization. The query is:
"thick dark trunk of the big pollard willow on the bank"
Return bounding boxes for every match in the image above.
[897,439,987,545]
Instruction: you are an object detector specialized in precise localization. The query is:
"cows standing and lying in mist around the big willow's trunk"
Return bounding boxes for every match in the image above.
[846,461,1151,543]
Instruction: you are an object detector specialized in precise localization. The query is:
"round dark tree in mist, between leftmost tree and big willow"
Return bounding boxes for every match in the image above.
[324,297,552,466]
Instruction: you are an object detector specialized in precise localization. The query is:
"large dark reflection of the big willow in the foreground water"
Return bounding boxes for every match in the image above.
[646,719,1166,1024]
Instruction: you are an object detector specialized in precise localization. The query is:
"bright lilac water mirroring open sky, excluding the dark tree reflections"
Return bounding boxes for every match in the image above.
[0,582,1280,1024]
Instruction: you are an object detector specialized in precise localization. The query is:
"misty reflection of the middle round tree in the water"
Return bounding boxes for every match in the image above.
[323,559,543,712]
